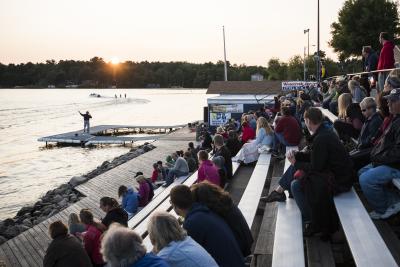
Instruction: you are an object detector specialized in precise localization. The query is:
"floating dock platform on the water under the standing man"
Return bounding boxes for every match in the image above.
[38,124,186,146]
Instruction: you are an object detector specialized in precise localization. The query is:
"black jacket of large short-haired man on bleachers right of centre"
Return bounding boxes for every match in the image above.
[294,125,353,192]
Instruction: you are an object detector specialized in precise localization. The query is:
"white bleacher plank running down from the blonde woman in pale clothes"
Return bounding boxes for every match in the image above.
[238,154,271,227]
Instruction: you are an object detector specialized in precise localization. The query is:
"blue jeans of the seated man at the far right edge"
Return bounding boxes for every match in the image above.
[358,164,400,213]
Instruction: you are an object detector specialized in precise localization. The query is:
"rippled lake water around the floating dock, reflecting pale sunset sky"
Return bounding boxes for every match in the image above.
[0,89,207,219]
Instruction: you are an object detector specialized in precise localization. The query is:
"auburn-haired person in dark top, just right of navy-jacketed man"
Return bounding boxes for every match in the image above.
[190,182,254,256]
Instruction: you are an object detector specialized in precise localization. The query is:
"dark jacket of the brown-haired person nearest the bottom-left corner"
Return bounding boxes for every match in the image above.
[43,235,92,267]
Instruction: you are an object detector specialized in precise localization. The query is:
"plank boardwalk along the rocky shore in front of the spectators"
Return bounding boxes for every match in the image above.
[0,127,195,267]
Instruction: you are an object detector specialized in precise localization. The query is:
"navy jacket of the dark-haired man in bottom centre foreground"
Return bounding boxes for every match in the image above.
[183,203,244,267]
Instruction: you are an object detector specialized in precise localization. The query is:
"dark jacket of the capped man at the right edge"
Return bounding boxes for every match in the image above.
[371,115,400,168]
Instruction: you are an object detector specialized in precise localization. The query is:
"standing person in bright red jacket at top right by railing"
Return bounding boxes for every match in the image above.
[377,32,394,91]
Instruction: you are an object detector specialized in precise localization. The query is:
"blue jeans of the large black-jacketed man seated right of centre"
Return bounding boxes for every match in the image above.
[279,165,311,222]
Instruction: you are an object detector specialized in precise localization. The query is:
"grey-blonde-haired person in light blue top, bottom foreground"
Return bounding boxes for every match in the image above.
[147,212,218,267]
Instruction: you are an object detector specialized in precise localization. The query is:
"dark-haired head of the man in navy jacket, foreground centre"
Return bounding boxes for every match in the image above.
[169,184,193,217]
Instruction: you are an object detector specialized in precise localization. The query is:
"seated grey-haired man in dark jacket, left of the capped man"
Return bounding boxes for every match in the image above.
[350,97,382,171]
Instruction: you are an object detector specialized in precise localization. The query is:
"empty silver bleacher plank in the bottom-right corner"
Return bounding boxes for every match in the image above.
[334,188,398,267]
